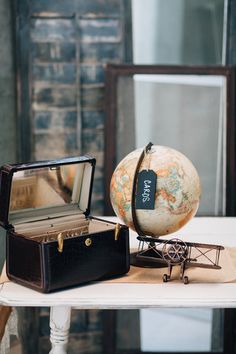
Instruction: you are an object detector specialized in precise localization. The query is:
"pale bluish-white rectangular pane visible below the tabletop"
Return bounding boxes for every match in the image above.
[140,309,215,352]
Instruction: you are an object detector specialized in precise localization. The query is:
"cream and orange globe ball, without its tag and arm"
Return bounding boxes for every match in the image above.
[110,145,201,237]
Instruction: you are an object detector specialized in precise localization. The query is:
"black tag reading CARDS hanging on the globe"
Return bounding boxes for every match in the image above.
[136,170,157,210]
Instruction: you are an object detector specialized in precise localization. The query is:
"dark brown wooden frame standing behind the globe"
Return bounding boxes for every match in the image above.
[104,64,236,216]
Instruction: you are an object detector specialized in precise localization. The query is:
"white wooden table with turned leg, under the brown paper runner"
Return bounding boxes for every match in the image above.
[0,218,236,354]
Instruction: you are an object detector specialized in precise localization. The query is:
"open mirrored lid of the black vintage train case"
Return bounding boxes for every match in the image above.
[0,156,96,228]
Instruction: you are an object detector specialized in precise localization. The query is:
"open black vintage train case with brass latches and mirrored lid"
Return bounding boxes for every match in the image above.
[0,156,129,293]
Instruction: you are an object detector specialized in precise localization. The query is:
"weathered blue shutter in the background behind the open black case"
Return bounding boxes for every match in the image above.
[18,0,131,214]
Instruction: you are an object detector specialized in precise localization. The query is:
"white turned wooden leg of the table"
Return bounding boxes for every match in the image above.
[49,306,71,354]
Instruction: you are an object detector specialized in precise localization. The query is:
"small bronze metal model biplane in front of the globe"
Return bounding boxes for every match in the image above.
[132,236,224,284]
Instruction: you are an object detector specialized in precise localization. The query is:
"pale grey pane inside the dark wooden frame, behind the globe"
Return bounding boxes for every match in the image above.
[134,75,226,215]
